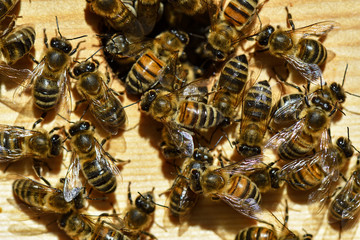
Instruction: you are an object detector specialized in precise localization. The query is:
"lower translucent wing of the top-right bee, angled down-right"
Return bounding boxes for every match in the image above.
[282,54,324,85]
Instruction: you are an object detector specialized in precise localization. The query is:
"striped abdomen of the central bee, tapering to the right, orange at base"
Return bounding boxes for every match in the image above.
[176,101,224,129]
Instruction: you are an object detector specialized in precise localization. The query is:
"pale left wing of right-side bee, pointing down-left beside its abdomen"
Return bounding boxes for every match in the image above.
[264,119,305,149]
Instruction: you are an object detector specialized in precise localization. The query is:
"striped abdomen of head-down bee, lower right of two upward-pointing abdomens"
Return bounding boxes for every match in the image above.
[244,80,272,122]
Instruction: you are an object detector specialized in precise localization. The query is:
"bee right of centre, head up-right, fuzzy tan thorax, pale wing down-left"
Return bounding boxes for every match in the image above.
[265,92,337,161]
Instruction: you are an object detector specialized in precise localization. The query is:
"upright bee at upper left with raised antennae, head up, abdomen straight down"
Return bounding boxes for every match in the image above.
[14,18,84,125]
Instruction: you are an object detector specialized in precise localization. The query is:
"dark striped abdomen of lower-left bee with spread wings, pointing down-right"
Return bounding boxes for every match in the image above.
[80,159,117,193]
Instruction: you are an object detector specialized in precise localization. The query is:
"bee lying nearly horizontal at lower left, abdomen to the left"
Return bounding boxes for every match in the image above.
[12,178,84,214]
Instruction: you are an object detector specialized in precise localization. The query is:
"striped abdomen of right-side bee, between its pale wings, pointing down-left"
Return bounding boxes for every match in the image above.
[278,130,317,160]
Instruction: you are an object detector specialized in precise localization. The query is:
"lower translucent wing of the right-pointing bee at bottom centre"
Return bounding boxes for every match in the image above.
[216,193,261,219]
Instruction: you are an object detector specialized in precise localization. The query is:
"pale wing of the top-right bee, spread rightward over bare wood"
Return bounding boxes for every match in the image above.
[287,21,340,37]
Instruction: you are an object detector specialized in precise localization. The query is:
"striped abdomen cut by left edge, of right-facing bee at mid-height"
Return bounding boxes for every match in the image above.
[0,128,25,160]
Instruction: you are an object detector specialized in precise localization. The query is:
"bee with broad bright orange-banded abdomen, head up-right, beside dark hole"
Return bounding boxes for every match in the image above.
[125,30,189,95]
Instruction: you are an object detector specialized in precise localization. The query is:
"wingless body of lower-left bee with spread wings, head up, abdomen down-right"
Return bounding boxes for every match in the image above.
[69,121,117,193]
